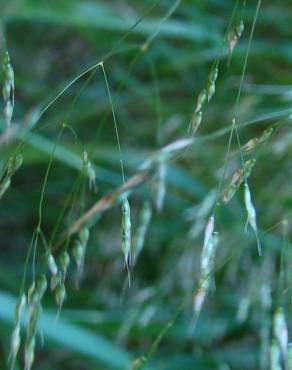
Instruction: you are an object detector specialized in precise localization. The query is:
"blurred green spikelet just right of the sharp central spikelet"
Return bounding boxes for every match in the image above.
[132,201,152,264]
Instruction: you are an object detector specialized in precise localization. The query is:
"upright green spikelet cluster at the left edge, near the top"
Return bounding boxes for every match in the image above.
[2,50,14,127]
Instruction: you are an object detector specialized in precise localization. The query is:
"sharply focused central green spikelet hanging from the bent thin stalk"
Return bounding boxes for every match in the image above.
[121,198,131,285]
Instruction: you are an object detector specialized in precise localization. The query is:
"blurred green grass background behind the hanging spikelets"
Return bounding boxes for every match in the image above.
[0,0,292,370]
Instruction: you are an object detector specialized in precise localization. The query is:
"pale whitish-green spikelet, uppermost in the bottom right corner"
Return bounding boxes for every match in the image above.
[273,307,288,363]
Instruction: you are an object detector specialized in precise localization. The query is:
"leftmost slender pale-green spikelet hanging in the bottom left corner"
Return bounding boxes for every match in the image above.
[9,294,26,369]
